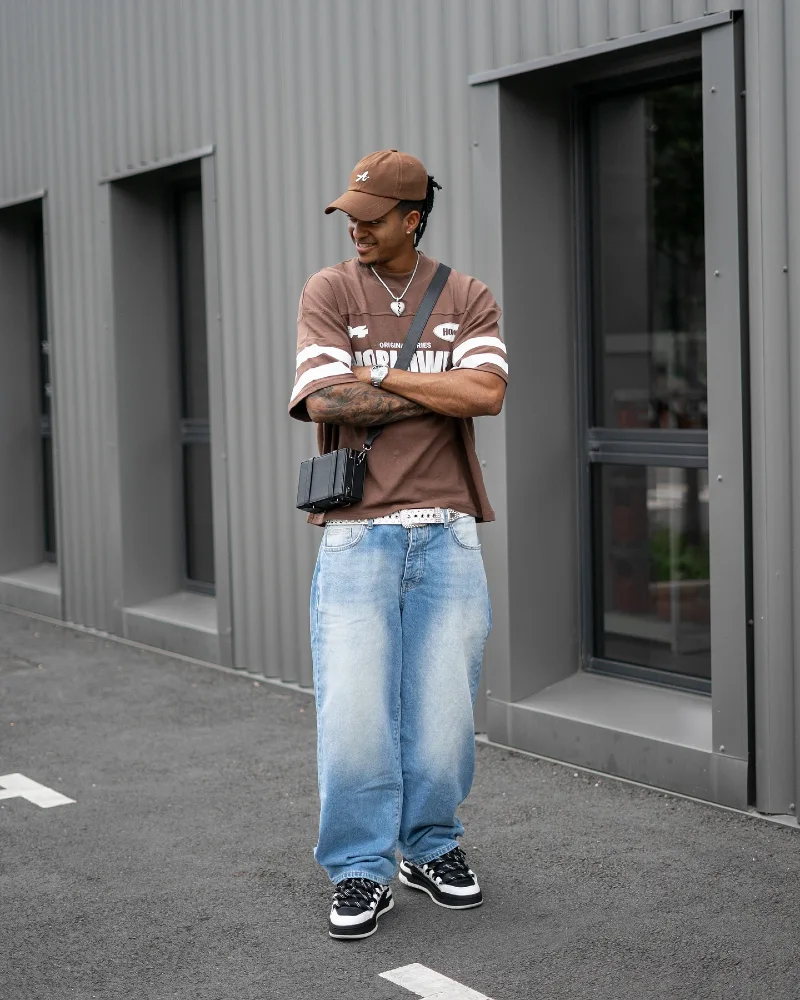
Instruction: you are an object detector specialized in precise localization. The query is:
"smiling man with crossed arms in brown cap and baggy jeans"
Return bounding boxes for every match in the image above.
[289,149,508,939]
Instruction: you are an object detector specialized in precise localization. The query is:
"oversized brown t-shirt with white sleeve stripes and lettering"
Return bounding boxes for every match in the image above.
[289,255,508,524]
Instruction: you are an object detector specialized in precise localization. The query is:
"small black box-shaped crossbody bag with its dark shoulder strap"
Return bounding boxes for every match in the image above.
[297,264,450,514]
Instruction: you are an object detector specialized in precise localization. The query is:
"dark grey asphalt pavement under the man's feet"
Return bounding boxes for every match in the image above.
[0,611,800,1000]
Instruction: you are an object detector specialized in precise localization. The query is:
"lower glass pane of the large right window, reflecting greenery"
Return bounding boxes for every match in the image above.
[596,465,711,678]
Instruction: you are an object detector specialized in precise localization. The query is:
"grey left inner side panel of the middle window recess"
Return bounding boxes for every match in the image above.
[110,179,183,607]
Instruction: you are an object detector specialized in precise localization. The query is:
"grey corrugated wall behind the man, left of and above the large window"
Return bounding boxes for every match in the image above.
[0,0,736,683]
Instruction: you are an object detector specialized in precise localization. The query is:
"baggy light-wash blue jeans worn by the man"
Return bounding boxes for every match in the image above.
[311,517,491,884]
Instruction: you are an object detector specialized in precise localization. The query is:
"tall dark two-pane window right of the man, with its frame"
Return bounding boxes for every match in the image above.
[586,78,711,690]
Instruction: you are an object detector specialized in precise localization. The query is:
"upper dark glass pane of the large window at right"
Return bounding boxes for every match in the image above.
[589,81,708,430]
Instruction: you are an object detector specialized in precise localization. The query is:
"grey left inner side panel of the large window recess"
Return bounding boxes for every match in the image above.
[499,81,579,701]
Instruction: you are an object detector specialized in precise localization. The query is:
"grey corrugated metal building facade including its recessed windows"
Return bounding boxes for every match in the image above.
[0,0,800,821]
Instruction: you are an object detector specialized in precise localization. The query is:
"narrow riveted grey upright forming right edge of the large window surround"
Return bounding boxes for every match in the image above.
[703,24,750,761]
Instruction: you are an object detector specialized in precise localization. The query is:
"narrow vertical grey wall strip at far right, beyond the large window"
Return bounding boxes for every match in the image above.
[745,0,797,814]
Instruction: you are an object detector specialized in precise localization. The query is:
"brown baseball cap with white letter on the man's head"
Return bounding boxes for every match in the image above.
[325,149,428,222]
